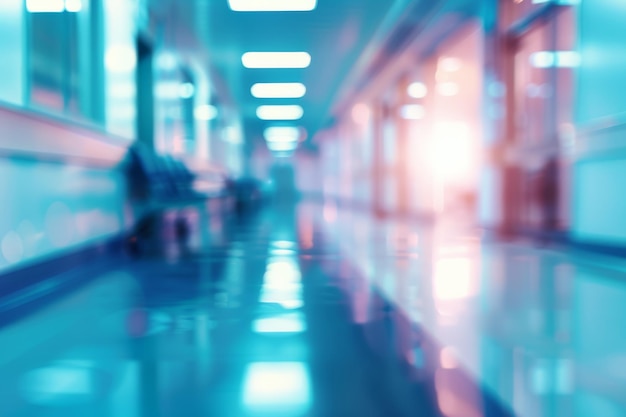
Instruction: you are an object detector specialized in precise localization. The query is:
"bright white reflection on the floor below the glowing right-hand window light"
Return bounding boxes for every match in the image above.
[433,258,475,300]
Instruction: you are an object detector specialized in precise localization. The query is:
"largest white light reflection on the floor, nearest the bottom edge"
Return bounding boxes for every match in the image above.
[243,362,311,415]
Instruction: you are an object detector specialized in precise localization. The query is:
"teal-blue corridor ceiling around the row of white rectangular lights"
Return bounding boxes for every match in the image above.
[153,0,408,149]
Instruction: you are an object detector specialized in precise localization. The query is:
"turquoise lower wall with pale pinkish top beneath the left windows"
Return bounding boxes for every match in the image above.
[0,107,127,273]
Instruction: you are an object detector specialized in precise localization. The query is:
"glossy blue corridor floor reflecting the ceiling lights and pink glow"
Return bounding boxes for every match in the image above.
[0,203,626,417]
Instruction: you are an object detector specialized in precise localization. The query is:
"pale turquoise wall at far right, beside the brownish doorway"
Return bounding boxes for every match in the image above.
[571,0,626,245]
